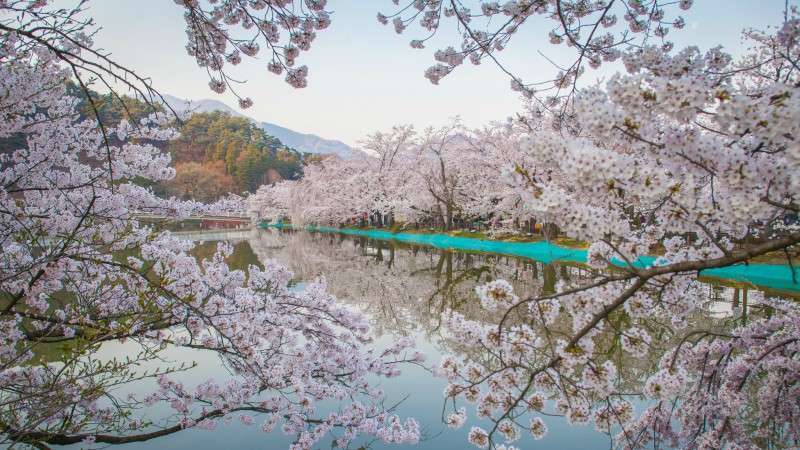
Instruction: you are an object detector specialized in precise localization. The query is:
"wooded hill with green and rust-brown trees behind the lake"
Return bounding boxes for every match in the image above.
[64,86,303,202]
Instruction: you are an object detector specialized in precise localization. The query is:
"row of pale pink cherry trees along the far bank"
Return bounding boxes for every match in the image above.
[250,121,532,229]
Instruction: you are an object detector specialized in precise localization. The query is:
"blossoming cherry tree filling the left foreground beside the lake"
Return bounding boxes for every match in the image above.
[0,1,419,449]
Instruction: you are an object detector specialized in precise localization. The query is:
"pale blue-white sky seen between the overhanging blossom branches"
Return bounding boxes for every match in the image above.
[67,0,800,145]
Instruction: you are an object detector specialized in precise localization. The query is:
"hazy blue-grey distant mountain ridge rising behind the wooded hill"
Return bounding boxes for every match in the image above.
[164,95,353,159]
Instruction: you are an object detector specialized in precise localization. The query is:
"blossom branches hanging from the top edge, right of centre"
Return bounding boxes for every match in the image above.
[377,0,693,106]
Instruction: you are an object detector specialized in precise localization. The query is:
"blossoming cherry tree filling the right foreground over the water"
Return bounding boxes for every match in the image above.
[434,12,800,448]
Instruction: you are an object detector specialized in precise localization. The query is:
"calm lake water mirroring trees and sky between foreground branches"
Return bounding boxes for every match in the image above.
[64,229,788,450]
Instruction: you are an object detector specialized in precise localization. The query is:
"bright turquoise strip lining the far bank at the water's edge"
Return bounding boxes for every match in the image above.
[259,223,800,296]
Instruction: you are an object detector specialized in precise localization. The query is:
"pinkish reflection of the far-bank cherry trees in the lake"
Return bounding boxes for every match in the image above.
[249,229,780,335]
